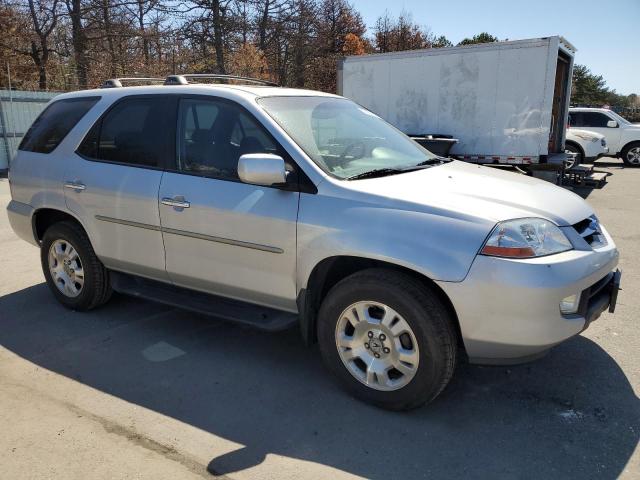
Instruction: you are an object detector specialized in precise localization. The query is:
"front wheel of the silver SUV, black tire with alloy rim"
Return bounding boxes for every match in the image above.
[318,269,457,410]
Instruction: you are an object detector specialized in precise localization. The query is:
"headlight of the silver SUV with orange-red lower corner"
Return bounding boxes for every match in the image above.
[480,218,573,258]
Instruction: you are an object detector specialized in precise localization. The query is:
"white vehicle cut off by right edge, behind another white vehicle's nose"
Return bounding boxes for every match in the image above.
[569,107,640,167]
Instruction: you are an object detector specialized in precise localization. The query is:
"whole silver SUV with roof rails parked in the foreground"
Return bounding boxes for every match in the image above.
[8,76,620,409]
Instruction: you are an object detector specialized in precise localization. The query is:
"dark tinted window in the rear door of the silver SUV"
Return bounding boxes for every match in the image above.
[78,96,174,167]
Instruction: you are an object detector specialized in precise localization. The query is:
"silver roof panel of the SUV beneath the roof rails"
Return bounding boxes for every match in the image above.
[55,83,341,100]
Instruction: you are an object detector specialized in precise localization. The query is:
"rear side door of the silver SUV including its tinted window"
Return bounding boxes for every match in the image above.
[65,95,177,281]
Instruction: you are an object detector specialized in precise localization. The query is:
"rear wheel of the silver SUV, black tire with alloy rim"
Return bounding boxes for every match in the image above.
[40,222,112,311]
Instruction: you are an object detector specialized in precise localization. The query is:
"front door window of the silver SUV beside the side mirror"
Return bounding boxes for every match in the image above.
[178,99,277,180]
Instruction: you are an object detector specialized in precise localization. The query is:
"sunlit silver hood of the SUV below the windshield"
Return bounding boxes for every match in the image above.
[343,160,593,226]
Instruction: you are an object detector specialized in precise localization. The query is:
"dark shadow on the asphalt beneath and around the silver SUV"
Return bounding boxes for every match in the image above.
[0,284,640,479]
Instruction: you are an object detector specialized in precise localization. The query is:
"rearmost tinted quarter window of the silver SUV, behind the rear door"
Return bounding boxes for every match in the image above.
[18,97,100,153]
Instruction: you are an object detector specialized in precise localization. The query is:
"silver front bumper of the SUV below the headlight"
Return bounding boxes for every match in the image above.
[438,234,619,363]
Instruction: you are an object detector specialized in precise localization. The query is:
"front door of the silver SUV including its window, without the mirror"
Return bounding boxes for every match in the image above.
[160,97,299,311]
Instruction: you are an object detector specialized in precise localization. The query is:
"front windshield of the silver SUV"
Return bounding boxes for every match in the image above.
[258,96,437,179]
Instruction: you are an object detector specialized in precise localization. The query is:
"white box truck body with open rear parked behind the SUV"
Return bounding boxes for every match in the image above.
[338,36,576,165]
